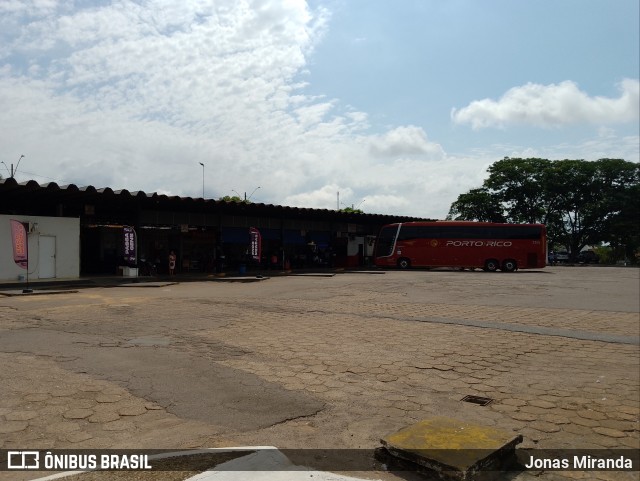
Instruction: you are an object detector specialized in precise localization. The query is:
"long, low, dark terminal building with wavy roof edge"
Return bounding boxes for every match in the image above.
[0,178,423,281]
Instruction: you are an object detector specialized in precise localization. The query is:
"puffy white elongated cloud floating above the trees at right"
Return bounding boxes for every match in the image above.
[451,79,640,129]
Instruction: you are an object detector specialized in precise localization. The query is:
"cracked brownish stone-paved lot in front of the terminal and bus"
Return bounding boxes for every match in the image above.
[0,266,640,479]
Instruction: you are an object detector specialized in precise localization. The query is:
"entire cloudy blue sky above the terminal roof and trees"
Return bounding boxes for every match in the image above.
[0,0,640,219]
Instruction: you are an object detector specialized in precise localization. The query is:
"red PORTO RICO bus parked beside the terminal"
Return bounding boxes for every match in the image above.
[375,221,547,272]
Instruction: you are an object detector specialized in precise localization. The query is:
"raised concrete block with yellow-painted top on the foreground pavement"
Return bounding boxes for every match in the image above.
[381,417,522,480]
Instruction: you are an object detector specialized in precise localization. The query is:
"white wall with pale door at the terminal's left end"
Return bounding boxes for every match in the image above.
[0,215,80,281]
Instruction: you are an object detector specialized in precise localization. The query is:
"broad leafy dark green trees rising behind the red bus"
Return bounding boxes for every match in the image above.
[447,157,640,259]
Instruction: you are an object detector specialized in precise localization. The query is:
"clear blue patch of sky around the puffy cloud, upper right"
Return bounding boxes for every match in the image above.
[310,0,640,148]
